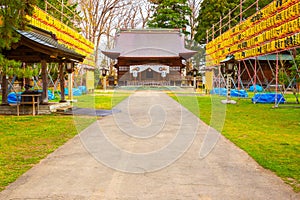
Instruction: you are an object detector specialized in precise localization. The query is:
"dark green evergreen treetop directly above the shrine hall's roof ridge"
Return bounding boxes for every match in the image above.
[147,0,191,33]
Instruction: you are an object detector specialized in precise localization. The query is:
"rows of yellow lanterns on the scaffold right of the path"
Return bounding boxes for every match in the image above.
[206,0,300,67]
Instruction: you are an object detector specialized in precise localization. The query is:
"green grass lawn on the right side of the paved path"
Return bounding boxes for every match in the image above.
[170,94,300,192]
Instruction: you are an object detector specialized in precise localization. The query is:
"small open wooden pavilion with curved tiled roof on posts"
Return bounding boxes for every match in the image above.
[3,28,85,104]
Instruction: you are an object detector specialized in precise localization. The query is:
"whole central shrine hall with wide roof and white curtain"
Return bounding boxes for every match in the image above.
[102,29,197,85]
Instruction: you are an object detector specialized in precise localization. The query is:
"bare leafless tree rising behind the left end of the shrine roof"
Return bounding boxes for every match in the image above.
[79,0,151,67]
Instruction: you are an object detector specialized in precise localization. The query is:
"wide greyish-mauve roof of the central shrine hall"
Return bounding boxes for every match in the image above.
[102,29,197,59]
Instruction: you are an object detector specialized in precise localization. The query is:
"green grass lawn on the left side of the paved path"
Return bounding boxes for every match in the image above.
[0,91,128,191]
